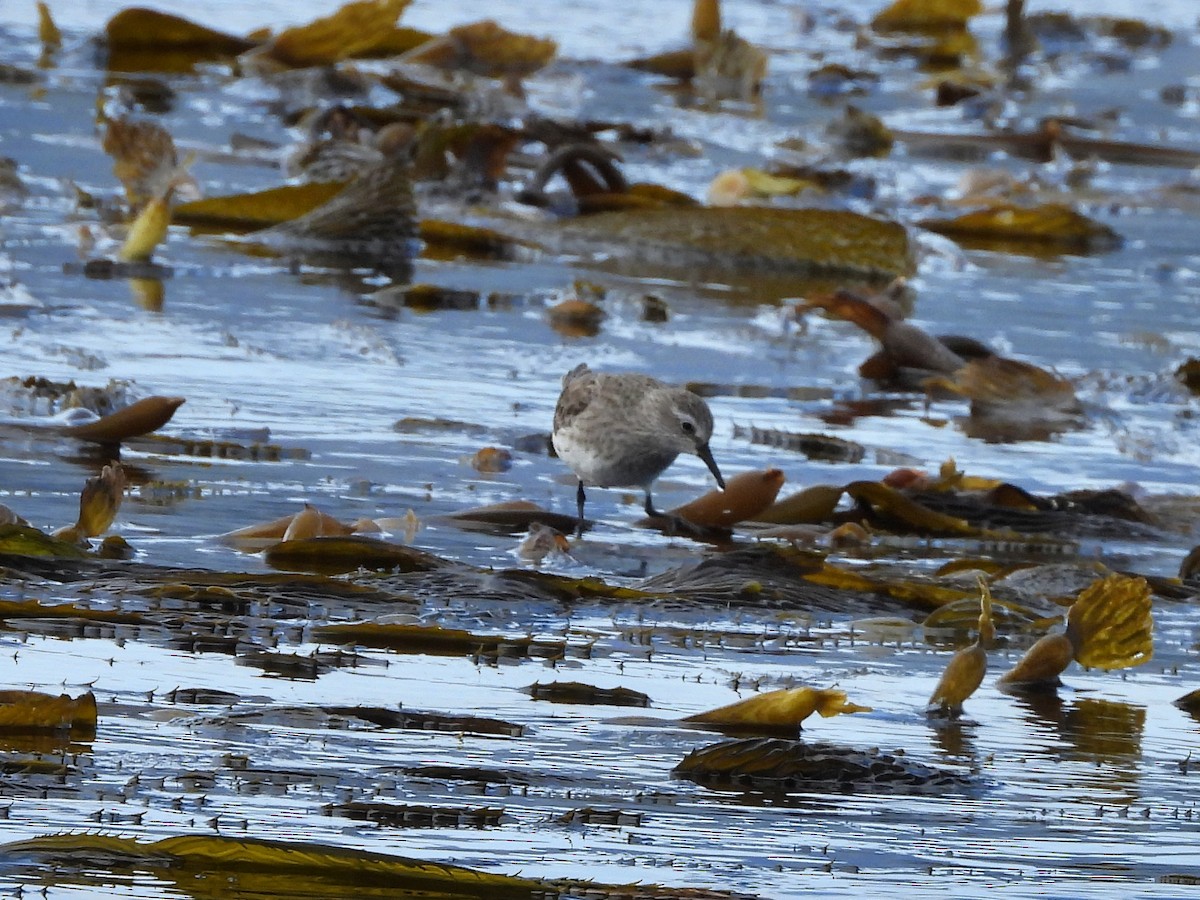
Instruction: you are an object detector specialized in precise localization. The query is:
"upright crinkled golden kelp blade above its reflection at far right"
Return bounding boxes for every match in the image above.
[1067,574,1154,668]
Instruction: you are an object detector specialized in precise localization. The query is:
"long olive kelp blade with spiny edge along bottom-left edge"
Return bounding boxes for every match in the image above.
[0,834,546,900]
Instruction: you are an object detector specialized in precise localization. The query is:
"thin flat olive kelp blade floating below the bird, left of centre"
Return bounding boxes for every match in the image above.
[312,622,566,658]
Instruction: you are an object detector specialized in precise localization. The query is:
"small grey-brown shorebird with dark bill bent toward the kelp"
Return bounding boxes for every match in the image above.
[553,364,725,534]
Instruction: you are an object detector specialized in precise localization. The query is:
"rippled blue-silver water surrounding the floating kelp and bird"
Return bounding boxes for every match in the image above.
[0,1,1200,898]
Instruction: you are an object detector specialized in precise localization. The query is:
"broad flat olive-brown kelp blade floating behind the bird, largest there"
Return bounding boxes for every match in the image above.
[558,206,913,281]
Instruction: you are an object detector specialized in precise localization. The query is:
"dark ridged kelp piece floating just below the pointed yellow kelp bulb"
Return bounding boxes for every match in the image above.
[671,738,972,793]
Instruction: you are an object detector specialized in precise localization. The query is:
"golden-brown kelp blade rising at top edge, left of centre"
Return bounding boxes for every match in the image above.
[260,0,409,68]
